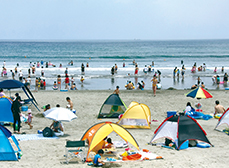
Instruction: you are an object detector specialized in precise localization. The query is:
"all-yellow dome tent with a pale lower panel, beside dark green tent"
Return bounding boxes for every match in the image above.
[118,101,151,129]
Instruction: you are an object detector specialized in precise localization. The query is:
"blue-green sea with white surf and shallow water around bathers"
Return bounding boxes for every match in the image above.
[0,40,229,90]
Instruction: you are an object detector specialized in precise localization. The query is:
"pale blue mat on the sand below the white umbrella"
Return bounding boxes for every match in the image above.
[14,134,59,141]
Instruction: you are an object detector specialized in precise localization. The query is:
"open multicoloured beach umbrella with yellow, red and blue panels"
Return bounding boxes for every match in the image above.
[186,87,213,99]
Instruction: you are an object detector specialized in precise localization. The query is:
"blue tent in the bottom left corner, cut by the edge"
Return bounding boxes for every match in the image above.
[0,125,21,161]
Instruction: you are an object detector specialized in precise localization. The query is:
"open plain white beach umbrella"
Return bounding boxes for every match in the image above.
[43,107,77,122]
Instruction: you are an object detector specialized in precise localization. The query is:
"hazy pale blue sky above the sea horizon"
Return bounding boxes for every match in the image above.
[0,0,229,40]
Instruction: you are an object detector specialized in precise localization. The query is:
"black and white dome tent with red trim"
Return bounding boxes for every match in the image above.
[150,116,211,150]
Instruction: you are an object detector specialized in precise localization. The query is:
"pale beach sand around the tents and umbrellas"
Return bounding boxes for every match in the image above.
[0,90,229,168]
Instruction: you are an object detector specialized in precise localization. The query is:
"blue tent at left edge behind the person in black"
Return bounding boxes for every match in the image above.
[0,96,14,123]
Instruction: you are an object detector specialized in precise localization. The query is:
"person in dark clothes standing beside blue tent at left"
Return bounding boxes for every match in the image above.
[11,96,21,134]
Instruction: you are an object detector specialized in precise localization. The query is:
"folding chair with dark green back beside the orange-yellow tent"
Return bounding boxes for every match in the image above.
[65,141,86,164]
